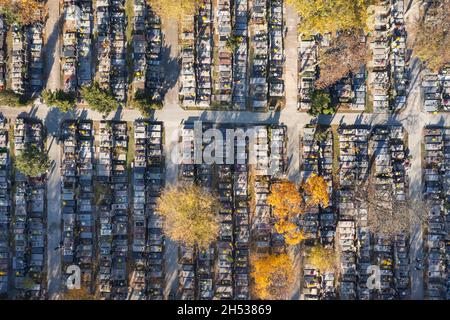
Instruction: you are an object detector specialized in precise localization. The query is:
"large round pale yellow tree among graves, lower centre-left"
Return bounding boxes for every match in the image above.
[157,184,221,248]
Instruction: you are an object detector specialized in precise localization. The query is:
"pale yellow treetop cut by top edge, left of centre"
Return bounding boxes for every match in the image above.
[147,0,200,22]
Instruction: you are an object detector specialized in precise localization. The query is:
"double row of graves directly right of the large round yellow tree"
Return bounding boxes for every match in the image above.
[215,124,256,300]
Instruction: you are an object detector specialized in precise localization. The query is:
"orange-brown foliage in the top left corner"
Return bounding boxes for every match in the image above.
[0,0,44,25]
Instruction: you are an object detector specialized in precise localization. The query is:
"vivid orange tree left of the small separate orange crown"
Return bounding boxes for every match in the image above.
[267,181,304,245]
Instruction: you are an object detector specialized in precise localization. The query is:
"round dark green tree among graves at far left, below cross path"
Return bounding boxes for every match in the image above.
[16,144,50,178]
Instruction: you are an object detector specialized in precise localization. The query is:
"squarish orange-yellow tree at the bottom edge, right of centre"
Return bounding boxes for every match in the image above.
[251,253,294,300]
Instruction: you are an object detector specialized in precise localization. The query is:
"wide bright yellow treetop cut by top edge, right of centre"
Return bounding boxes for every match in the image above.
[287,0,374,35]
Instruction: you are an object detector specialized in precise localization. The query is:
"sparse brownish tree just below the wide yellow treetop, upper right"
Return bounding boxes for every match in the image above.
[315,31,367,89]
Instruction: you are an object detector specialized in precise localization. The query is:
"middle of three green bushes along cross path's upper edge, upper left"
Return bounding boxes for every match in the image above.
[81,82,119,115]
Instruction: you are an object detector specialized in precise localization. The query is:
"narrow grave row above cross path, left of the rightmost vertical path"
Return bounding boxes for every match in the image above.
[391,0,408,111]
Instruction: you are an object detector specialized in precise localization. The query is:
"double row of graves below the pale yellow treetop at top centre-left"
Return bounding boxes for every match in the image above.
[179,0,213,108]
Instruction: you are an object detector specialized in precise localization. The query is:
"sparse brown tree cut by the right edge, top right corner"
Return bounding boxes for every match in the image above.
[413,0,450,72]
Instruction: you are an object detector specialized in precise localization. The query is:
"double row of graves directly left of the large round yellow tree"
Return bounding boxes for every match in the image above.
[129,120,165,300]
